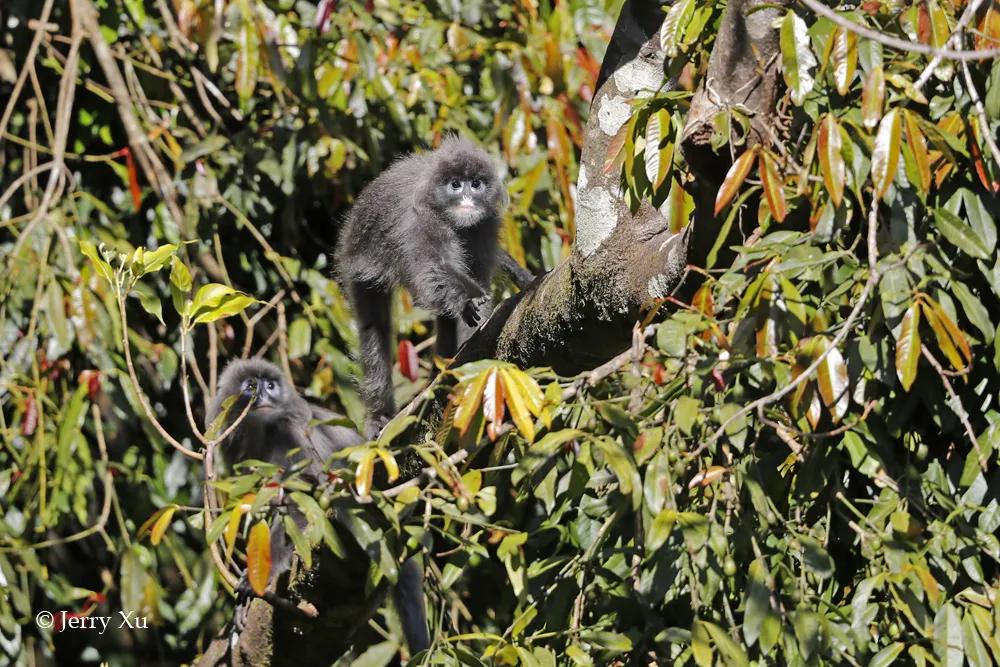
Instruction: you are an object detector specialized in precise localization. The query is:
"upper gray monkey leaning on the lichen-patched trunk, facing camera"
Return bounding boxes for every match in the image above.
[336,136,534,438]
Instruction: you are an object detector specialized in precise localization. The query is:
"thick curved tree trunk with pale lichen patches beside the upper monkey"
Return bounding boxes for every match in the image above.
[456,0,686,374]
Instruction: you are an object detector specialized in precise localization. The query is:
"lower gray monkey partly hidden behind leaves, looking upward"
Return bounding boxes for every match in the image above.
[205,359,430,653]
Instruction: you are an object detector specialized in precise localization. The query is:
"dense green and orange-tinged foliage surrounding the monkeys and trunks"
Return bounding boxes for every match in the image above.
[0,0,1000,665]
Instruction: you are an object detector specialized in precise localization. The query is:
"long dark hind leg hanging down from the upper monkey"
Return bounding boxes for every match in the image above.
[351,283,396,438]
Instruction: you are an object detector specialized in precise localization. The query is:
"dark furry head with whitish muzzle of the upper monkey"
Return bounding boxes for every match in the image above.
[427,137,507,229]
